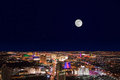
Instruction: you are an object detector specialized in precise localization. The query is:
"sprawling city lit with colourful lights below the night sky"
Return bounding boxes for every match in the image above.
[0,51,120,80]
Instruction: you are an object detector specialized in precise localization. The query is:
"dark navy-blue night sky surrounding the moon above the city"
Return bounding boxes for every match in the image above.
[0,0,120,51]
